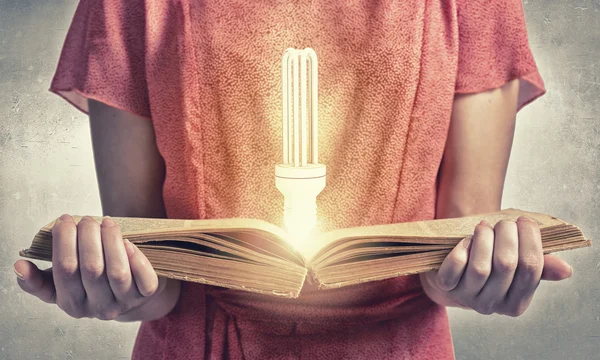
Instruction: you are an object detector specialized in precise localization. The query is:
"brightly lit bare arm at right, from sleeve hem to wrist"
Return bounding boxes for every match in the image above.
[420,81,518,306]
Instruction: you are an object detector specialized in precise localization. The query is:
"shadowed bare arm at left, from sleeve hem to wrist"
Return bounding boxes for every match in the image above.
[89,101,181,321]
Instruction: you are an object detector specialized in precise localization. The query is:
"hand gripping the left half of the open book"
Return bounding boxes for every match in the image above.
[14,214,180,321]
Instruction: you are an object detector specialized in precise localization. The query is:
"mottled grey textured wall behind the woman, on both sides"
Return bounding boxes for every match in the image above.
[0,0,600,359]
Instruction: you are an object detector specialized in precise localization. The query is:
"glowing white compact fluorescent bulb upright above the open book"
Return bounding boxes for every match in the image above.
[275,48,325,239]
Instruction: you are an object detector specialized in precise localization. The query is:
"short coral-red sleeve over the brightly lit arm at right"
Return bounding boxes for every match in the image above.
[456,0,546,109]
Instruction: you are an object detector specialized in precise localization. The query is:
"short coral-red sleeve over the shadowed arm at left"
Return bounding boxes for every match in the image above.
[50,0,150,118]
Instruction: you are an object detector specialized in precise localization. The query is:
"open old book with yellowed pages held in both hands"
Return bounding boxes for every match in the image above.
[20,209,591,298]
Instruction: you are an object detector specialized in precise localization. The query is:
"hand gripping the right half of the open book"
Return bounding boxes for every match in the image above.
[421,217,573,316]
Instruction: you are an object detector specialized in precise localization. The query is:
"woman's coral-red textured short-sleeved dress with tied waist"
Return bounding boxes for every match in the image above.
[51,0,544,359]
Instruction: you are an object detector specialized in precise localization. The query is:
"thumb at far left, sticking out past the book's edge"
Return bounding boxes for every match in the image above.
[13,260,56,303]
